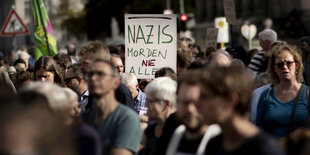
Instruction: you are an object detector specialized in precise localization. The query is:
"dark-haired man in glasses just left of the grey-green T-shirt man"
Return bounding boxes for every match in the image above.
[65,64,89,112]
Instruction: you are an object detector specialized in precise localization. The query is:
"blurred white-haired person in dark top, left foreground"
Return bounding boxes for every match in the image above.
[18,82,102,154]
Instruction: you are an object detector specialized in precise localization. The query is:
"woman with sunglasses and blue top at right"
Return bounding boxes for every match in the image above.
[256,45,308,137]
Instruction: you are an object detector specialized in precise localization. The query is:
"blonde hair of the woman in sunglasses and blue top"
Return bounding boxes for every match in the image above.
[268,45,304,85]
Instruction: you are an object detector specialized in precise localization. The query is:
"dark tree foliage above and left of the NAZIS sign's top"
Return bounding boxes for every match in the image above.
[63,0,195,39]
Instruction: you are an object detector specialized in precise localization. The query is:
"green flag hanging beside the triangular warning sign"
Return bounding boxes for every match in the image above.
[32,0,57,60]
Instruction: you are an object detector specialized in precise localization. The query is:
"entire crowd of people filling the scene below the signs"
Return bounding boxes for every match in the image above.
[0,29,310,155]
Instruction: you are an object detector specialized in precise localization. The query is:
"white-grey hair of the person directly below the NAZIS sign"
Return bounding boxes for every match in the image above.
[145,77,177,108]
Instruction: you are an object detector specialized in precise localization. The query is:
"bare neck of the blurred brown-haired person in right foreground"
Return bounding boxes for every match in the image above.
[220,115,259,150]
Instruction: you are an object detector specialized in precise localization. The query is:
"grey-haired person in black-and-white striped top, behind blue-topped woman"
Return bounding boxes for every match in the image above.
[248,29,277,76]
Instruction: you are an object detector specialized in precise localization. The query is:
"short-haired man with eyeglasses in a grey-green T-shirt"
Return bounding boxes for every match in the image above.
[84,60,142,155]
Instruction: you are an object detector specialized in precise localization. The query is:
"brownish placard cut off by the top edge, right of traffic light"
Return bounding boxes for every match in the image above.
[224,0,236,25]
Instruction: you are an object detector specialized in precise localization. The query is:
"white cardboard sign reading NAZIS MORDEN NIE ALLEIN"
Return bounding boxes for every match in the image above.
[125,14,177,79]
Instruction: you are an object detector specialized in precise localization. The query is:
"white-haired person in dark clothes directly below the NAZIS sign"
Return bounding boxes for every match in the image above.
[141,77,177,154]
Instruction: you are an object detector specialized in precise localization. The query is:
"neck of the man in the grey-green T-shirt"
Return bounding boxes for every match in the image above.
[95,92,119,121]
